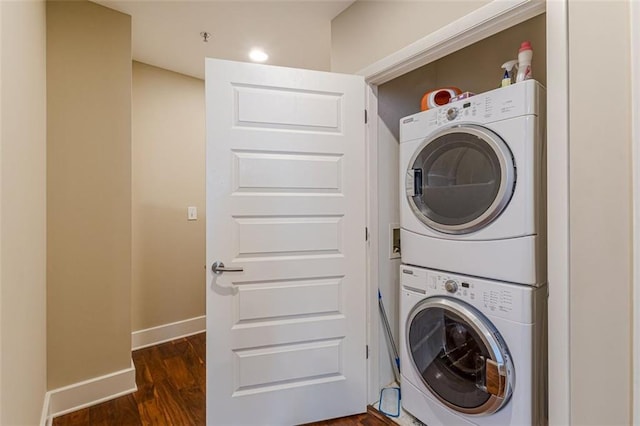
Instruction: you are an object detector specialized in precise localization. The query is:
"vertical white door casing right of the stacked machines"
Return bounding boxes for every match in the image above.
[547,0,571,425]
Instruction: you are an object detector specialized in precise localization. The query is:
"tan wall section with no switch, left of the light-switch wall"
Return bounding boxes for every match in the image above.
[47,1,131,389]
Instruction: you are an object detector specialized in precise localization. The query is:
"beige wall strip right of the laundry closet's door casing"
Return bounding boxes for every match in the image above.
[568,2,632,425]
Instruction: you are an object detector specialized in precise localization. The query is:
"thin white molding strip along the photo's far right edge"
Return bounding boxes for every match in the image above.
[629,0,640,426]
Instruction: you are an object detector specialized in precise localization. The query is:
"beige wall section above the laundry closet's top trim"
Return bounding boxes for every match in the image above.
[331,0,488,73]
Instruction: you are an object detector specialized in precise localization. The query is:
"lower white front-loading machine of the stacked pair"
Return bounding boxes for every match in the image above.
[400,265,548,426]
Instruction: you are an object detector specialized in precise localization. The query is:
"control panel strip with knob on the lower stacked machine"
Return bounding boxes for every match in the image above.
[400,265,546,323]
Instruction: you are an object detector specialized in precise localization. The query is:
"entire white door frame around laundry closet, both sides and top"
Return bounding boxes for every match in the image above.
[357,0,572,424]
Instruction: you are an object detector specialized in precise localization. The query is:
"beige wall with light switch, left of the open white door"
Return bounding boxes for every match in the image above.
[132,62,206,331]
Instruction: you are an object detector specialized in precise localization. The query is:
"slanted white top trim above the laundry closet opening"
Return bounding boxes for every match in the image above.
[357,0,546,85]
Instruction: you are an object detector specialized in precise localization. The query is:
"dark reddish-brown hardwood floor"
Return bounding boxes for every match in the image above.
[53,333,394,426]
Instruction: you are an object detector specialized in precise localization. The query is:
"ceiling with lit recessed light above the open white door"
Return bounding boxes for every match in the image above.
[93,0,353,79]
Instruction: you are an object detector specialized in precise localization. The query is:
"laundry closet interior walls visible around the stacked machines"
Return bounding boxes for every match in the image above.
[375,10,547,412]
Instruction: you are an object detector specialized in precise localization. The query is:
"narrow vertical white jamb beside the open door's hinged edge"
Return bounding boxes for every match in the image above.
[366,81,380,403]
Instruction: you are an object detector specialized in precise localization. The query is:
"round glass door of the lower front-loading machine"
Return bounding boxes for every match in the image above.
[405,297,515,415]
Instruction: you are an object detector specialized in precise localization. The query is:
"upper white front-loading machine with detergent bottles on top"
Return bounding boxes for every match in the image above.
[400,80,546,285]
